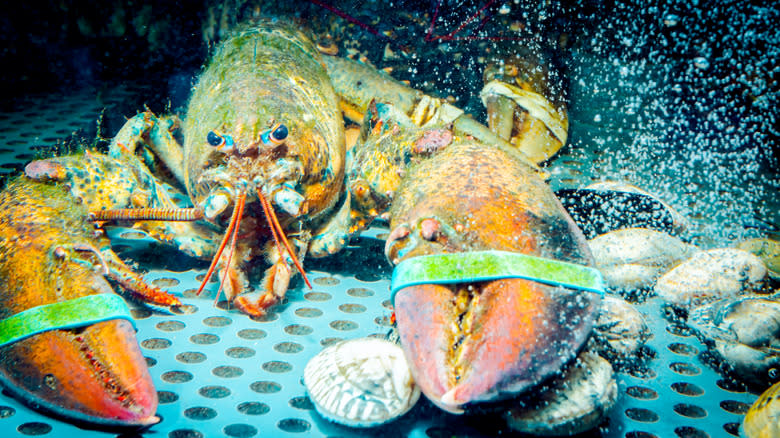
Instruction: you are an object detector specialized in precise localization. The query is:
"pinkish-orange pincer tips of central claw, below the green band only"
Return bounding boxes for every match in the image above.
[395,279,600,413]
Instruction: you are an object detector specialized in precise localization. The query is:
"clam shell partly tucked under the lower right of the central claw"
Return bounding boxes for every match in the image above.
[506,351,617,436]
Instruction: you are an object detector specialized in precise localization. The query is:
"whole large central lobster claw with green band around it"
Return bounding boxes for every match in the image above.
[385,139,601,413]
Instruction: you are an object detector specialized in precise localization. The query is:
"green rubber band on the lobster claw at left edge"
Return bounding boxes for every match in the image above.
[0,293,135,347]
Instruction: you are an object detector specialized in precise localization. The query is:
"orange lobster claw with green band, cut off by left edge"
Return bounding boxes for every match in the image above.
[0,177,163,427]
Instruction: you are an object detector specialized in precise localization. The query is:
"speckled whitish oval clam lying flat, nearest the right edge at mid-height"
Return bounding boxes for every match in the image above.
[655,248,767,308]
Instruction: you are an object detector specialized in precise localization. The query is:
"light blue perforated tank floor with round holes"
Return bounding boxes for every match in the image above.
[0,83,768,438]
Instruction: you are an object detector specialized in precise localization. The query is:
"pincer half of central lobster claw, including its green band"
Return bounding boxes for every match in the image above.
[393,251,600,413]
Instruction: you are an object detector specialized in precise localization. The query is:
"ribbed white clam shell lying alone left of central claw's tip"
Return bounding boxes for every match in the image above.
[303,338,420,427]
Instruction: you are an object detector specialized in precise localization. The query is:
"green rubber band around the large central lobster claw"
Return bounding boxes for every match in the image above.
[390,251,604,303]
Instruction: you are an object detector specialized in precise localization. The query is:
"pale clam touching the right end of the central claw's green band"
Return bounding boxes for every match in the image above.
[588,228,697,291]
